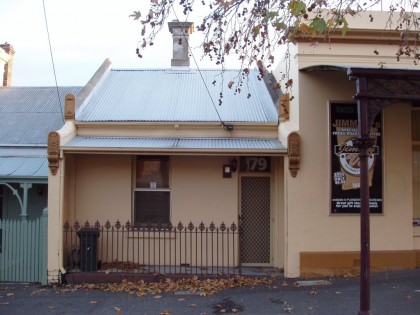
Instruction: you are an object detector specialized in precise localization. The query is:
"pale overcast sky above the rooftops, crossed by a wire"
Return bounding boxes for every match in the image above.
[0,0,400,86]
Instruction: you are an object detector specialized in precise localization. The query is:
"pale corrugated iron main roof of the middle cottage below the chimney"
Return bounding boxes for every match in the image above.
[76,69,278,124]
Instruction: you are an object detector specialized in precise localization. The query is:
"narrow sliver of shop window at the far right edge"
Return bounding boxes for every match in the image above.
[411,108,420,225]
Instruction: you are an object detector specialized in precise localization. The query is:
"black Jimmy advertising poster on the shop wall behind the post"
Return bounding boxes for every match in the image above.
[330,103,383,213]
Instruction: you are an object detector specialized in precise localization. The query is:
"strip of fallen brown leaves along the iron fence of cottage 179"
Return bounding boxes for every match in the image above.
[75,276,273,298]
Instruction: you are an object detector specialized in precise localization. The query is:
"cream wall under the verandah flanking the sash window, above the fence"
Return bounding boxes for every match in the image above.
[67,155,238,224]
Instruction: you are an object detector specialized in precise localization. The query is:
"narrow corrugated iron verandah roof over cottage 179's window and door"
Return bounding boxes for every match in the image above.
[61,136,287,155]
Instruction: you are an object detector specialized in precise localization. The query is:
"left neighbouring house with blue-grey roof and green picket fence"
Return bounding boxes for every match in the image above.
[0,44,81,283]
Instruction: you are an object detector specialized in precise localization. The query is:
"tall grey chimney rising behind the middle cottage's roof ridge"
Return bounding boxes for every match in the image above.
[168,20,194,67]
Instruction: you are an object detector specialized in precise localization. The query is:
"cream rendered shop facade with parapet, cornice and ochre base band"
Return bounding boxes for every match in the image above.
[275,12,420,277]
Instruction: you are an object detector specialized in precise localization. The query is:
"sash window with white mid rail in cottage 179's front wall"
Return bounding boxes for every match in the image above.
[133,156,171,225]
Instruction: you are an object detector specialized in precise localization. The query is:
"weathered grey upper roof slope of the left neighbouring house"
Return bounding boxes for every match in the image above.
[0,87,81,146]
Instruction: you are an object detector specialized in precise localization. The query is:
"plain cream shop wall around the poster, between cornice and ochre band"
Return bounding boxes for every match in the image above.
[287,72,413,276]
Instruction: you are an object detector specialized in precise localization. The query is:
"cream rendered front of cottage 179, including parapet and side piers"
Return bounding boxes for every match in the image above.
[48,68,287,282]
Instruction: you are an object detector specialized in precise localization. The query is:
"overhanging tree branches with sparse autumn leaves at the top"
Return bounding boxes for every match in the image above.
[130,0,420,90]
